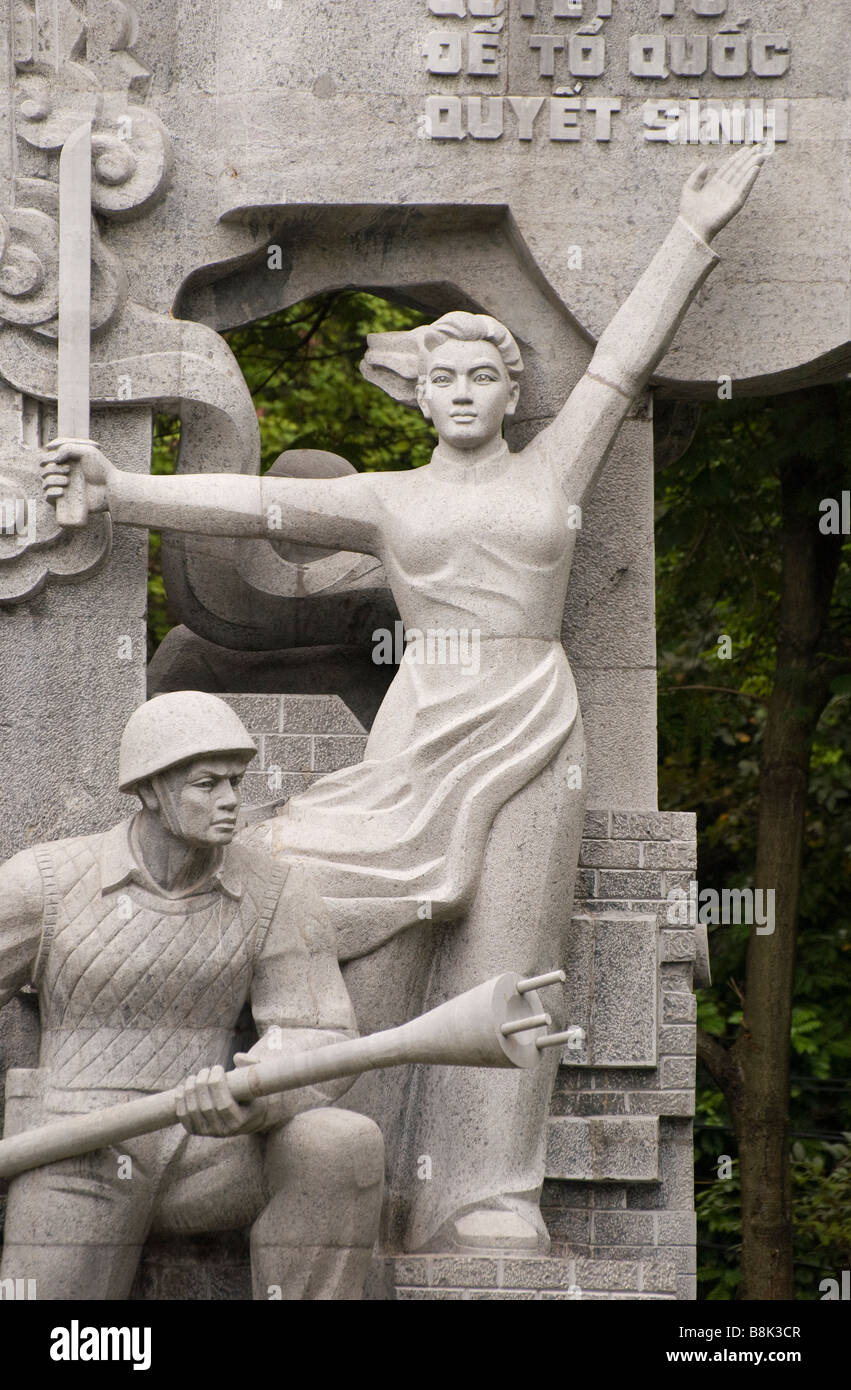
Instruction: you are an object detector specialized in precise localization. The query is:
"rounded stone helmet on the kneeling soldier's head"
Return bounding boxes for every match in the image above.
[118,691,257,791]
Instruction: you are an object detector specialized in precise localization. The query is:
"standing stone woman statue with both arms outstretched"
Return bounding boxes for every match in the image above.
[43,146,765,1251]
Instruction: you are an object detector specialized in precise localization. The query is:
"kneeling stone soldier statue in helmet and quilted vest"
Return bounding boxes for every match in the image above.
[0,691,384,1300]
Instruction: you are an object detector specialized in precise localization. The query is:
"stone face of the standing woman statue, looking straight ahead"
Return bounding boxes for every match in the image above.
[417,338,520,449]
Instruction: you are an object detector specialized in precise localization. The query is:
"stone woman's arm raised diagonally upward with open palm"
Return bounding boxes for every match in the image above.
[535,146,766,502]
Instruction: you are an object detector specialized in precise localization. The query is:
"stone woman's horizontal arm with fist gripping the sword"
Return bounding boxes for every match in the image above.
[42,439,378,555]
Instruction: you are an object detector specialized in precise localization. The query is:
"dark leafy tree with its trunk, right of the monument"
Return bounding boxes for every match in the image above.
[656,386,851,1298]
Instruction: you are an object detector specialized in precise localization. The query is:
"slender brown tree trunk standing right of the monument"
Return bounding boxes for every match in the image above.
[731,388,841,1300]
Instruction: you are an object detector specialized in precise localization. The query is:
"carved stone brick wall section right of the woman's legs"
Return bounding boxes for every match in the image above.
[542,810,708,1298]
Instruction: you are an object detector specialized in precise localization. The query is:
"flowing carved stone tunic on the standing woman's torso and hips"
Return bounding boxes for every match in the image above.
[243,445,577,960]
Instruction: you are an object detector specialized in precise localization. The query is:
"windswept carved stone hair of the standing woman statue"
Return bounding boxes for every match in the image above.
[360,310,523,406]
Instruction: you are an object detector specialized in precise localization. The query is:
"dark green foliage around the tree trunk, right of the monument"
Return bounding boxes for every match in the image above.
[656,388,851,1300]
